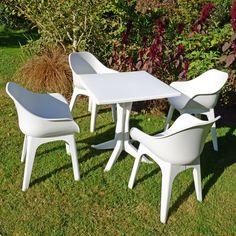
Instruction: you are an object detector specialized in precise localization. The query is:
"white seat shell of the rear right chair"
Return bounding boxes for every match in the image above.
[170,69,228,113]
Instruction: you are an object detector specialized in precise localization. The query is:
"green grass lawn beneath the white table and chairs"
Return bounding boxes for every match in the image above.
[0,27,236,235]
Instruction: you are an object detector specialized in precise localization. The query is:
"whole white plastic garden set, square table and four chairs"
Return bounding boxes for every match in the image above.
[6,52,228,223]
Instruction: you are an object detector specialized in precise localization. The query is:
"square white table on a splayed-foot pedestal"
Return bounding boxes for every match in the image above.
[81,71,180,171]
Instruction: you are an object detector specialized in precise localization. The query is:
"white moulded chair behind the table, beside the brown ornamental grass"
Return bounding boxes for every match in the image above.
[69,52,118,132]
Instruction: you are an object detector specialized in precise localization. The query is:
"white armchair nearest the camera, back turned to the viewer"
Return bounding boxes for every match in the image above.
[128,114,220,223]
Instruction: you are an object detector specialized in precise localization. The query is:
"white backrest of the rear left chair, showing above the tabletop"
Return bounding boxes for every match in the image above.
[69,52,114,75]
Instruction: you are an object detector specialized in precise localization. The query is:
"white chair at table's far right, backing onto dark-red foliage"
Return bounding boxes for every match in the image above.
[165,69,228,151]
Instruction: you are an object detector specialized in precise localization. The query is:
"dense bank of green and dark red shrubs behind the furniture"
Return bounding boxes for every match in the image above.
[1,0,236,107]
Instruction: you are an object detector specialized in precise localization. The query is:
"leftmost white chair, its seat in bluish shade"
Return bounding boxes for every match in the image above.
[6,82,80,191]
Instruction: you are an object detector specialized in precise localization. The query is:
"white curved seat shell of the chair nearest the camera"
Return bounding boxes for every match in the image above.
[131,114,220,165]
